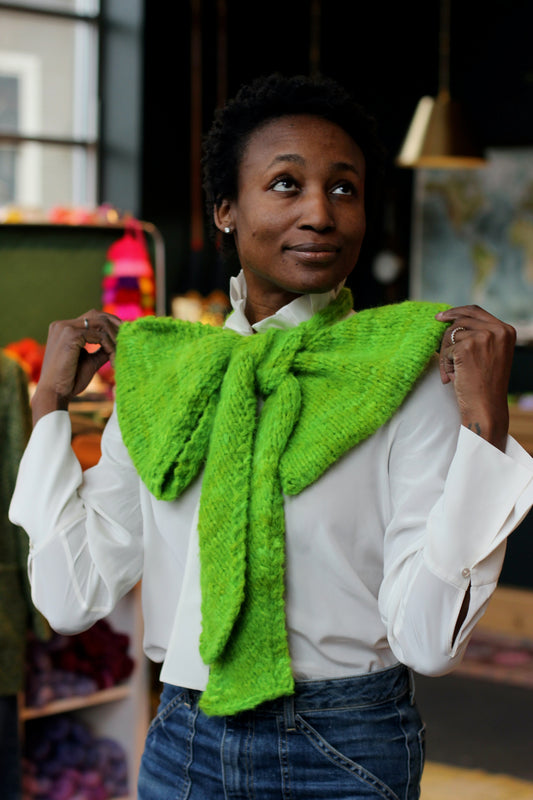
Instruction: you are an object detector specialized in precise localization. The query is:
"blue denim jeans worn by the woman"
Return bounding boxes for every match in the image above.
[138,666,424,800]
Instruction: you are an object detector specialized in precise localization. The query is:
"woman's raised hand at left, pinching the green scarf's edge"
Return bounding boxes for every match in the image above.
[32,310,121,425]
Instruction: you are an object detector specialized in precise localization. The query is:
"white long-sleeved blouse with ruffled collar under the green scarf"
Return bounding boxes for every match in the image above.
[10,276,533,689]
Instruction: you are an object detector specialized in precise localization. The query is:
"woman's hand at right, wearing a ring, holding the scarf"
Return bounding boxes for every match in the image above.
[436,305,516,451]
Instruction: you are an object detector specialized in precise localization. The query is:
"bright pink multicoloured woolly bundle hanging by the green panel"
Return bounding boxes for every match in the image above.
[102,223,155,320]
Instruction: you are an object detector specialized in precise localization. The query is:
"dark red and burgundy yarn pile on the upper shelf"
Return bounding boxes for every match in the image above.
[26,620,134,708]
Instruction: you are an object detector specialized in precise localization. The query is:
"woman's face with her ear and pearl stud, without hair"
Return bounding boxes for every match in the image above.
[215,115,365,318]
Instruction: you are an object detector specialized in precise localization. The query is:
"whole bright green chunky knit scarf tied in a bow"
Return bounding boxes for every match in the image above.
[115,289,446,714]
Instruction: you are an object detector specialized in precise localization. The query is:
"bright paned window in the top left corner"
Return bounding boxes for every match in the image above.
[0,0,100,210]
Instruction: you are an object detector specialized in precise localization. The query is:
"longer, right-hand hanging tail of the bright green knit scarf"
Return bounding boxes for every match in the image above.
[200,374,301,714]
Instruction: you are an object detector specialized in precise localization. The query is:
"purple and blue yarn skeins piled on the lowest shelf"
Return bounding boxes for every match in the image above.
[22,714,128,800]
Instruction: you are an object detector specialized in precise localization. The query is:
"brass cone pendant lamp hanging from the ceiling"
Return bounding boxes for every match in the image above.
[396,0,487,169]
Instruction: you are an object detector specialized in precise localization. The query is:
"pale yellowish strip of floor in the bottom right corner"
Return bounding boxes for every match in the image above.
[421,763,533,800]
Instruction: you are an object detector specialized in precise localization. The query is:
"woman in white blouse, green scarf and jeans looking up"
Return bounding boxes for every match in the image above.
[11,76,533,800]
